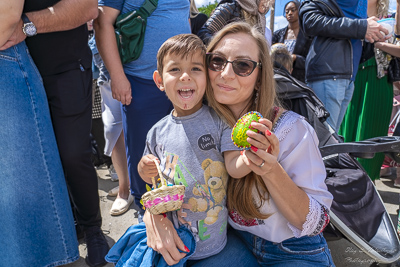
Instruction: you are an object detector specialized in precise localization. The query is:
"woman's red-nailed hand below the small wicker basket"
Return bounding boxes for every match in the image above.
[143,211,189,265]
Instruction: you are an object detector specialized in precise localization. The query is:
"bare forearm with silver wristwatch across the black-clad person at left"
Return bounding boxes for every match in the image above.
[0,0,98,50]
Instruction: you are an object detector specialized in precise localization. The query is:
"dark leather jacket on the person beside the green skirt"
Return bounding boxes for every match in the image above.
[299,0,368,82]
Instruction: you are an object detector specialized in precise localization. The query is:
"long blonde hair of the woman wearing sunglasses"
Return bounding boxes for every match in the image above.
[206,22,278,219]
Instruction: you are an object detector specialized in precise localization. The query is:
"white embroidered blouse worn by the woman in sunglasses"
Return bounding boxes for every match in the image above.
[229,111,333,242]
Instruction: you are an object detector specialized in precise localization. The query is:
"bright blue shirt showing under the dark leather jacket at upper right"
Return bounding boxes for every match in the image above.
[336,0,368,81]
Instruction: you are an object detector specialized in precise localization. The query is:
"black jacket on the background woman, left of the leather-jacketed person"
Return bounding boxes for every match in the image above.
[272,26,312,82]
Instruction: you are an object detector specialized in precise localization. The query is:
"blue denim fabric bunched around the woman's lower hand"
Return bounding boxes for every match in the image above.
[106,223,196,267]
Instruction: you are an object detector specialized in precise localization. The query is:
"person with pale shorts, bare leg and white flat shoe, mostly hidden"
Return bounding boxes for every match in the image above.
[91,36,133,216]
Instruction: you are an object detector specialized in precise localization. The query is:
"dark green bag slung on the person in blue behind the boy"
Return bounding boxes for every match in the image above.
[114,0,158,64]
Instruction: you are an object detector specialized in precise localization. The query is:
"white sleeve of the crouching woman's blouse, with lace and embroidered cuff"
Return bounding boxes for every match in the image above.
[278,114,333,237]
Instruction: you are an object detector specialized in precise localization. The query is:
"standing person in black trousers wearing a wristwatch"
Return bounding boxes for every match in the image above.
[0,0,109,266]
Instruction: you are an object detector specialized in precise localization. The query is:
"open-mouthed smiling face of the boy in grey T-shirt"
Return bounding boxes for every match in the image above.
[153,51,207,117]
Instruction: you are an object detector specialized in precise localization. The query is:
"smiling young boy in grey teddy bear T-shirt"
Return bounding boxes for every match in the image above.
[105,34,255,266]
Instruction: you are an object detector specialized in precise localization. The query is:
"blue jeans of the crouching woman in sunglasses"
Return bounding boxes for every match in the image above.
[237,231,335,267]
